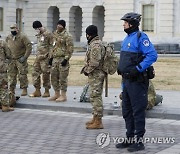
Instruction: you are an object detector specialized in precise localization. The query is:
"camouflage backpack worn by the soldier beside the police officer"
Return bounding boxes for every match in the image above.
[102,43,118,75]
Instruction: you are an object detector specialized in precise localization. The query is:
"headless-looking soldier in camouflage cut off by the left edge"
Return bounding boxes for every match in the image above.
[0,39,14,112]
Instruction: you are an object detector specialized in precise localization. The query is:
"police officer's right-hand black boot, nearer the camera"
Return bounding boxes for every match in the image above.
[127,138,145,152]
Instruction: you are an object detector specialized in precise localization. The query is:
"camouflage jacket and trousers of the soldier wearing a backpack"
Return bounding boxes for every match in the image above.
[83,36,105,117]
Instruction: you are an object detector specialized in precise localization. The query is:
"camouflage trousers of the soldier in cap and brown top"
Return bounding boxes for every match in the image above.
[8,60,28,89]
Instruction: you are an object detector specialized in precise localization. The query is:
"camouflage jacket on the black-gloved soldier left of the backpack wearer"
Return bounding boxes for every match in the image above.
[50,29,74,60]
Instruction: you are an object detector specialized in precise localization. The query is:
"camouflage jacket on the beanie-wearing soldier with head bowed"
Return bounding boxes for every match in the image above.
[36,29,53,59]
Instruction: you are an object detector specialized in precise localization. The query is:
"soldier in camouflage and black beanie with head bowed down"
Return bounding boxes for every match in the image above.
[30,20,53,97]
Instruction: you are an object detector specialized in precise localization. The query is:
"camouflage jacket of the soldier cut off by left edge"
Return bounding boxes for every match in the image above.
[0,40,11,73]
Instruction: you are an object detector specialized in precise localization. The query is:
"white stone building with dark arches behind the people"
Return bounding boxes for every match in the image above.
[0,0,180,47]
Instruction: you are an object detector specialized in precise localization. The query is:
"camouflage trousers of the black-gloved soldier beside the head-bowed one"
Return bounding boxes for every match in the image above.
[51,57,70,91]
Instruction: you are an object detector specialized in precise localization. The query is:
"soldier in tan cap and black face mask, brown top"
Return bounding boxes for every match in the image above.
[6,24,32,96]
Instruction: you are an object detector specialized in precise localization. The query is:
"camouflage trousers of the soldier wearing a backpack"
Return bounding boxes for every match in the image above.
[88,70,105,117]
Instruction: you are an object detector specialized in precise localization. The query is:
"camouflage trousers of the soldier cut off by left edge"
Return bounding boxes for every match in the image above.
[0,73,9,106]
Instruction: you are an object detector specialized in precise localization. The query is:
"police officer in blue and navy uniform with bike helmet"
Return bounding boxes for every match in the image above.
[116,13,157,152]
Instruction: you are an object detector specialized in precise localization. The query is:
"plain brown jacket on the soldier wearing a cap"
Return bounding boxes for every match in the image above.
[6,32,32,59]
